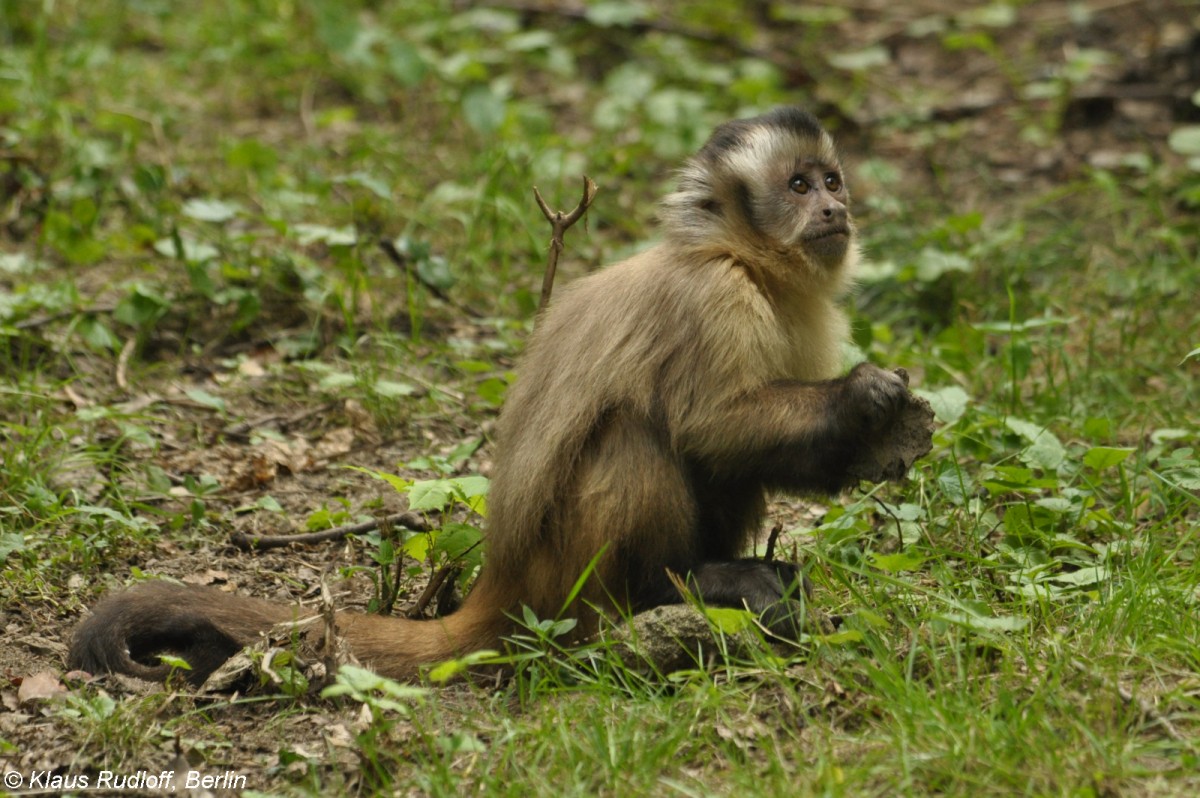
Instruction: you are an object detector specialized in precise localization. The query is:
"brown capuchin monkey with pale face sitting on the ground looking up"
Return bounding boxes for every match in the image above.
[70,108,907,684]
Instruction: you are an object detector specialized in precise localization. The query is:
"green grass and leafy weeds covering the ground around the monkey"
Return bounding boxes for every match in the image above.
[0,0,1200,796]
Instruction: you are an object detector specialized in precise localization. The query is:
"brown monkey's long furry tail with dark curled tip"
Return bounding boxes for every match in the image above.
[67,580,511,685]
